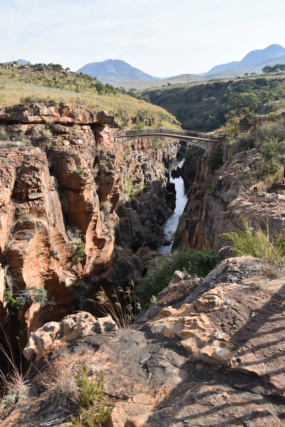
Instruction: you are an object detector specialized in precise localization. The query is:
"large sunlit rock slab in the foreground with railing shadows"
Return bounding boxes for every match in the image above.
[3,257,285,427]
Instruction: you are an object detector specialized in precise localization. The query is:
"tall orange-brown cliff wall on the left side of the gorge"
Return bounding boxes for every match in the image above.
[0,103,178,352]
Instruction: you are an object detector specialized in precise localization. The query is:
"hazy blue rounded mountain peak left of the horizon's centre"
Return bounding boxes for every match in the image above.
[77,59,160,83]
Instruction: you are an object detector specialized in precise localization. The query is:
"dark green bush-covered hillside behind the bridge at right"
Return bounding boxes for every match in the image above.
[142,73,285,131]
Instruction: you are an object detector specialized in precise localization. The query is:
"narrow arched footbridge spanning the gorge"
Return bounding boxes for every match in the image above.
[113,127,221,151]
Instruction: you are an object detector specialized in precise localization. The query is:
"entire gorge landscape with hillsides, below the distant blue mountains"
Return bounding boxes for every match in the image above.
[0,64,285,427]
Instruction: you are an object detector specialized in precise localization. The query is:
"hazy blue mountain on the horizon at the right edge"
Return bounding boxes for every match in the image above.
[204,44,285,76]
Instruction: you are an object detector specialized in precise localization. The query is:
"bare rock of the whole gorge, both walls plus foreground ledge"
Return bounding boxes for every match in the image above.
[0,103,285,427]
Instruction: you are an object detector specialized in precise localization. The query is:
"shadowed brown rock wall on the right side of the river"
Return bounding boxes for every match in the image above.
[177,144,285,251]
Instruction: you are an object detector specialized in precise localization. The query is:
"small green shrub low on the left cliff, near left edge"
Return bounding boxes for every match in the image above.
[4,286,47,313]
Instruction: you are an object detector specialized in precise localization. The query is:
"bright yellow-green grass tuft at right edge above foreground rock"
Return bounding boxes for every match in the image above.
[221,220,285,263]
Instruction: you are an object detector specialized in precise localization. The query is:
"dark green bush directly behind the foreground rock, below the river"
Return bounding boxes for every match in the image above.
[138,249,218,307]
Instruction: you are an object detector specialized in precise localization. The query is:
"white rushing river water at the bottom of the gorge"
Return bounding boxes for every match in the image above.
[158,159,187,254]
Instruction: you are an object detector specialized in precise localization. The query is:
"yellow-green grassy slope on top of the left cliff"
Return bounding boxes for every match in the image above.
[0,64,177,127]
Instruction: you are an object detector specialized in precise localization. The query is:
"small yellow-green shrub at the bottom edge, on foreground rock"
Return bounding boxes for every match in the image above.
[71,365,110,427]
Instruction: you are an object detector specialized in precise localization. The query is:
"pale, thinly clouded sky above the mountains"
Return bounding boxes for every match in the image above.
[0,0,285,77]
